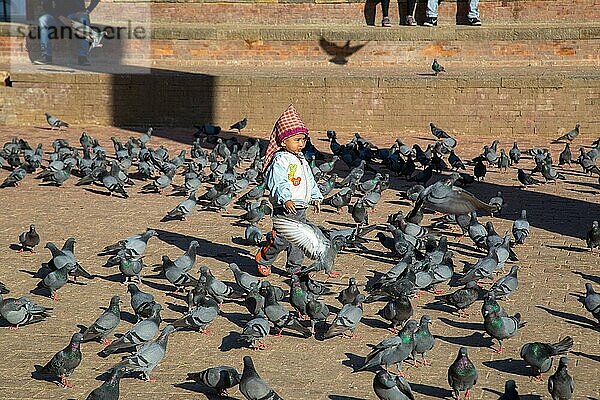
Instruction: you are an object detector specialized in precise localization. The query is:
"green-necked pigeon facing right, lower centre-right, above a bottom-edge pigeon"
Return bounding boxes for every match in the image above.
[357,319,417,371]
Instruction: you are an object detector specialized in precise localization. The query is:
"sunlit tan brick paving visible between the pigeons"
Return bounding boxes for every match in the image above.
[0,127,600,400]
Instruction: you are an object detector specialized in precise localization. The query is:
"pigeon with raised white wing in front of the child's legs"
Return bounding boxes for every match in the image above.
[273,216,345,278]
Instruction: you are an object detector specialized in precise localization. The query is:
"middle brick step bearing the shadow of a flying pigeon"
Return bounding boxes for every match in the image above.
[0,22,600,68]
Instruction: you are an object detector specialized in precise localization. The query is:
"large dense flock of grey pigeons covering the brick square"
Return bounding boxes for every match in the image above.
[0,113,600,400]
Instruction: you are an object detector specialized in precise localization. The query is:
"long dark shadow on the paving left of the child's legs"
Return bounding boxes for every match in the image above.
[155,229,250,268]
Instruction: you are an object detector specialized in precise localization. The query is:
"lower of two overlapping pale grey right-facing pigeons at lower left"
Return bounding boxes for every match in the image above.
[111,325,175,382]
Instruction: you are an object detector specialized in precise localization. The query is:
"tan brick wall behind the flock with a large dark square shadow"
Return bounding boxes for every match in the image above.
[0,74,600,135]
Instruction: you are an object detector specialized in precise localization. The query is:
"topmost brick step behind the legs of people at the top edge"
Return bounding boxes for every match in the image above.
[86,0,600,26]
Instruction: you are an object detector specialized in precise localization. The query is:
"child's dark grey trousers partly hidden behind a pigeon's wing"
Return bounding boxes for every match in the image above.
[257,207,306,271]
